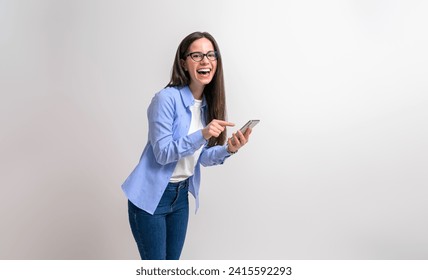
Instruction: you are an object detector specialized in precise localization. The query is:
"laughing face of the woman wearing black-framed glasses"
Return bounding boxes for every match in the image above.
[182,38,217,87]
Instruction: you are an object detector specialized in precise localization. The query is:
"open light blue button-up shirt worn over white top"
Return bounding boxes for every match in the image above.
[122,86,230,214]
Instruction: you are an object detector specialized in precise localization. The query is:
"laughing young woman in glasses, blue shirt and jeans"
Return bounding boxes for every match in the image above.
[122,32,251,259]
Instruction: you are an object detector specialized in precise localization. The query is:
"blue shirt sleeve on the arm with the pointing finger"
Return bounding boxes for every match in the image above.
[147,94,206,165]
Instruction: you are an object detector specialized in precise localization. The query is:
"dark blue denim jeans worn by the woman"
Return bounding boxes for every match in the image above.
[128,180,189,260]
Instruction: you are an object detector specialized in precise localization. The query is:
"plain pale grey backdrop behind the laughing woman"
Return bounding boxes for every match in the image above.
[0,0,428,259]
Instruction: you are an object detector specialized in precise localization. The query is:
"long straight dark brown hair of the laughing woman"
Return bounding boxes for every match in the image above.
[167,32,227,147]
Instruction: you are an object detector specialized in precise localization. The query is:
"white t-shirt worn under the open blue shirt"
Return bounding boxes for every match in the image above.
[169,99,204,183]
